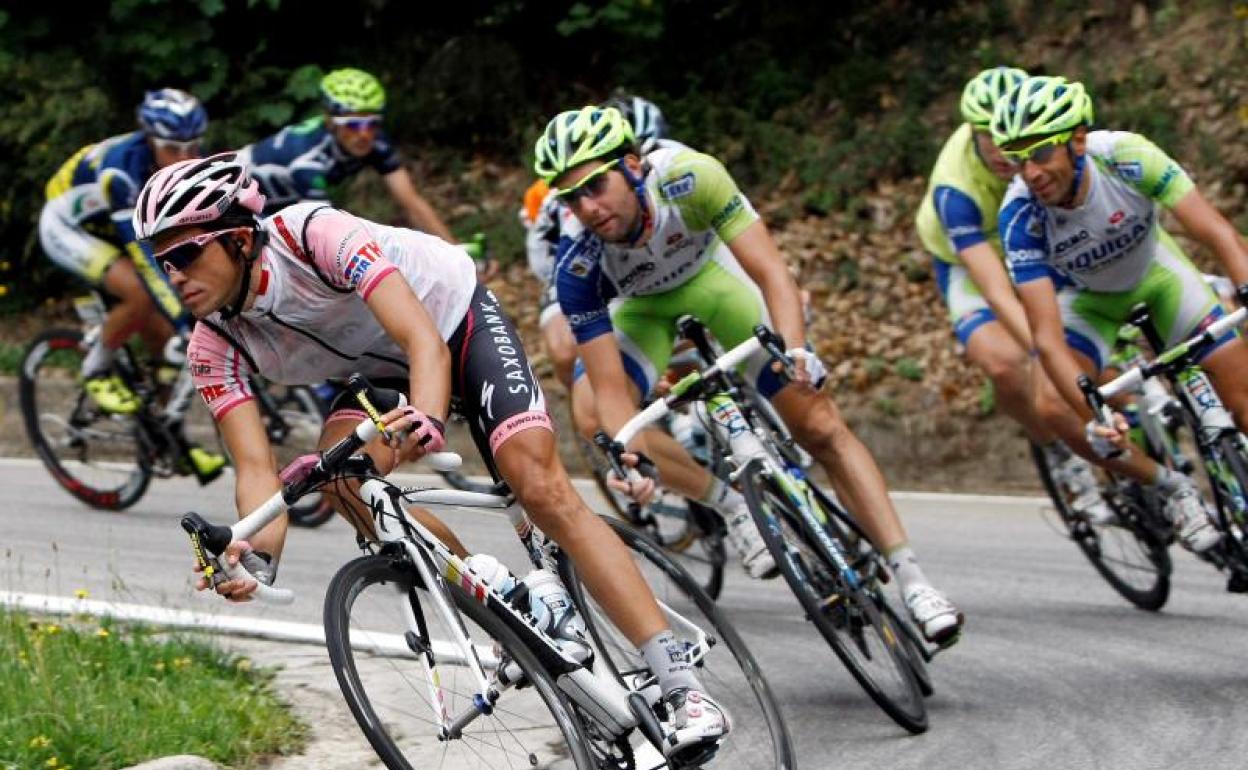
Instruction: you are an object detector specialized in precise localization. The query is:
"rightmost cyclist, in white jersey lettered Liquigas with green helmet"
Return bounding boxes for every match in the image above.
[992,77,1248,552]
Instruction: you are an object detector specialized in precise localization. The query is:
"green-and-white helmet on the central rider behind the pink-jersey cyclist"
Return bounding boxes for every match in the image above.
[533,106,636,183]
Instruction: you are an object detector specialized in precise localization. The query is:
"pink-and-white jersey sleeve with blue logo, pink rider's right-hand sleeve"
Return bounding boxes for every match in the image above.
[305,208,398,301]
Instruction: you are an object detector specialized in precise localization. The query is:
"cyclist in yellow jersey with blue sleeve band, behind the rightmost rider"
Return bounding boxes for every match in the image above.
[915,66,1113,523]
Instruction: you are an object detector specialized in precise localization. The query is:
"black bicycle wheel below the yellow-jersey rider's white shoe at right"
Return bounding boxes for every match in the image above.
[1031,444,1172,612]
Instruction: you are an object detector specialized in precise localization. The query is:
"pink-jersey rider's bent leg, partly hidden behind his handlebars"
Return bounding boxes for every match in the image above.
[317,379,469,557]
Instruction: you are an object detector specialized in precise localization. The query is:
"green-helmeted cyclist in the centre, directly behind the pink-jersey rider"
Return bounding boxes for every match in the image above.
[534,102,962,643]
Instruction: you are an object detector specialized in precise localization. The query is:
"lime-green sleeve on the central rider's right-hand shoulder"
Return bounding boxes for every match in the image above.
[659,151,759,243]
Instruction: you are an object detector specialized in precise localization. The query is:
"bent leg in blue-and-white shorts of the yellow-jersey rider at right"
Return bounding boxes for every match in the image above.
[932,257,1053,446]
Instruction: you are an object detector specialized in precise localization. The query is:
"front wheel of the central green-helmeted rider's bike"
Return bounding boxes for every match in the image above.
[741,459,927,734]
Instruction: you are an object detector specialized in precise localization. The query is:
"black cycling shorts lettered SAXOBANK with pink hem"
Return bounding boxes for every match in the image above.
[326,285,554,480]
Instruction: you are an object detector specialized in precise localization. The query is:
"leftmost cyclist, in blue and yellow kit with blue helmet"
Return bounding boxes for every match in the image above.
[39,89,212,444]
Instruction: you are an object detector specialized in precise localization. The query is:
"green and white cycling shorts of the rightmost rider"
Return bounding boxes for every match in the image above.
[1057,238,1236,369]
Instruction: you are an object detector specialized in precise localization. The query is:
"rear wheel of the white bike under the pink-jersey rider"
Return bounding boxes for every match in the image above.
[560,517,795,770]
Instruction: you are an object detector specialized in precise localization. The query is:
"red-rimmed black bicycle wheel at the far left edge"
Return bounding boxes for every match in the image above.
[17,328,151,510]
